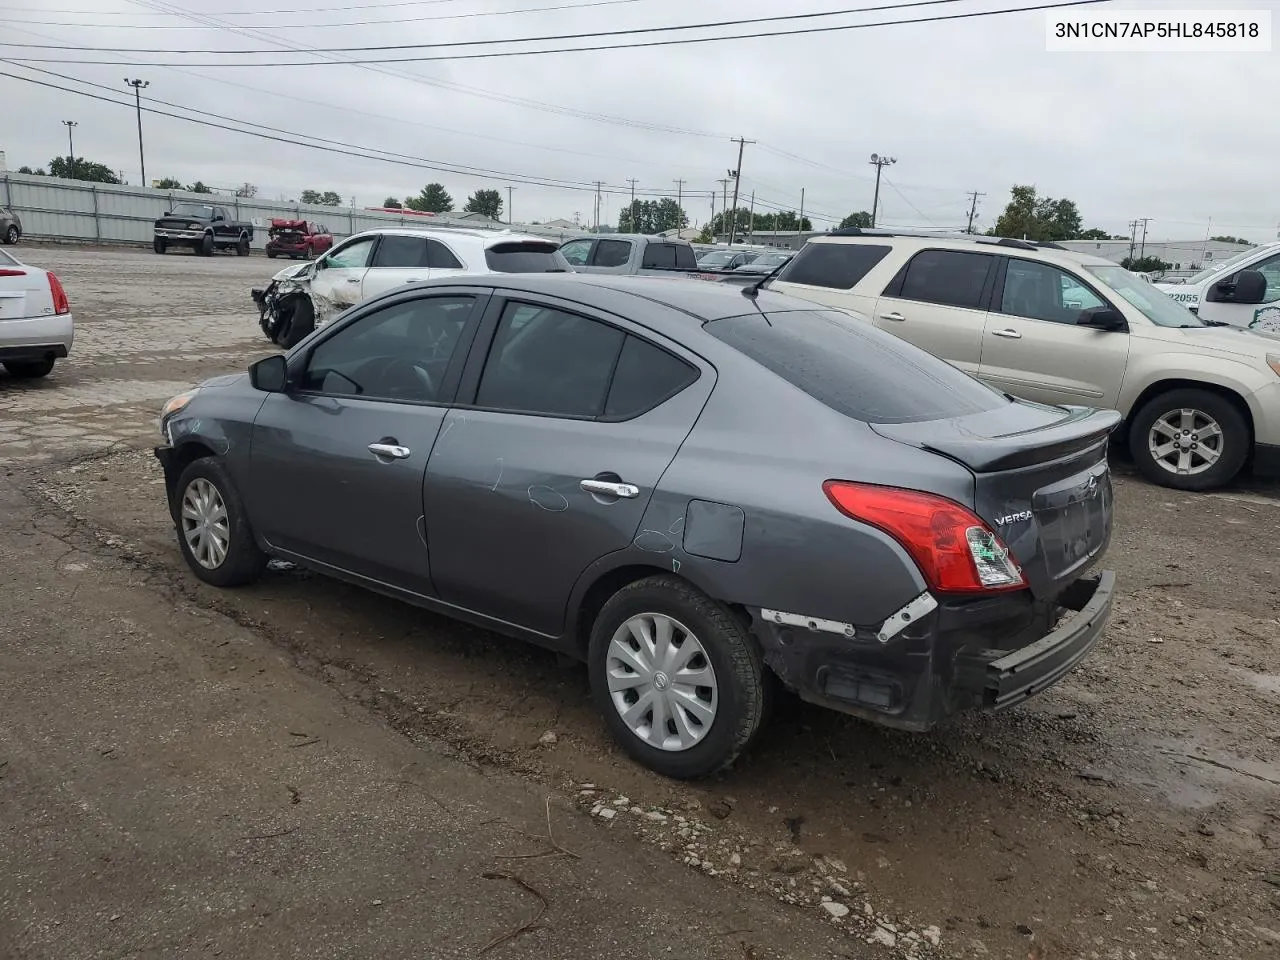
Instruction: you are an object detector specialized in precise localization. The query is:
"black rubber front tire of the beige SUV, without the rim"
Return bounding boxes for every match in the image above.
[1129,387,1253,490]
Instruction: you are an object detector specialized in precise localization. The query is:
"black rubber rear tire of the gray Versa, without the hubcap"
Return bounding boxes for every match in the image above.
[588,575,771,780]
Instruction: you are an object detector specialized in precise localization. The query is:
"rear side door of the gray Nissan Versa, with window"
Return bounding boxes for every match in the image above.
[425,300,714,636]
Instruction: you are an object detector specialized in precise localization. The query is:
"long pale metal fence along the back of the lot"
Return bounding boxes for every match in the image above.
[0,173,576,250]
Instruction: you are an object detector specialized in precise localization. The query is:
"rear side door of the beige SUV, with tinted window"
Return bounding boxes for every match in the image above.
[872,250,997,375]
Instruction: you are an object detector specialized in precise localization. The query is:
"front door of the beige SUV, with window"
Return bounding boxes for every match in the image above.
[979,257,1129,407]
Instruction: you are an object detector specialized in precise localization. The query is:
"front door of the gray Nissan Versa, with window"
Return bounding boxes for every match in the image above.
[247,293,479,594]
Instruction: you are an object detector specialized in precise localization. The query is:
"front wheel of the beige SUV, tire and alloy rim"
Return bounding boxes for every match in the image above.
[1129,388,1251,490]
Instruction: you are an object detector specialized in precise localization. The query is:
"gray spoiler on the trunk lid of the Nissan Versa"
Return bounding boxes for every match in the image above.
[870,403,1121,474]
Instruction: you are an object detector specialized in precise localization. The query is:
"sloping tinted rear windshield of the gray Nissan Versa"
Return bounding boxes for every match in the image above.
[703,310,1010,424]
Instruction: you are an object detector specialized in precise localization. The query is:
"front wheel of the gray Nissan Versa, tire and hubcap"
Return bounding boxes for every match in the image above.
[174,457,266,586]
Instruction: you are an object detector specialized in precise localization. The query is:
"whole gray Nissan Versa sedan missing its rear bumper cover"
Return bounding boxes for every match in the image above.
[156,274,1119,777]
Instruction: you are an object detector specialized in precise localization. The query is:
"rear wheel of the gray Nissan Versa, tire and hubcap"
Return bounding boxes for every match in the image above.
[588,575,769,780]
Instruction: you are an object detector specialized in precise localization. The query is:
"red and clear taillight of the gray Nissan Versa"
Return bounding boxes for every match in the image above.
[822,480,1027,594]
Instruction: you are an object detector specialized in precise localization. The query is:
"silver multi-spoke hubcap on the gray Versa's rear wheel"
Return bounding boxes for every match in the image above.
[604,613,719,751]
